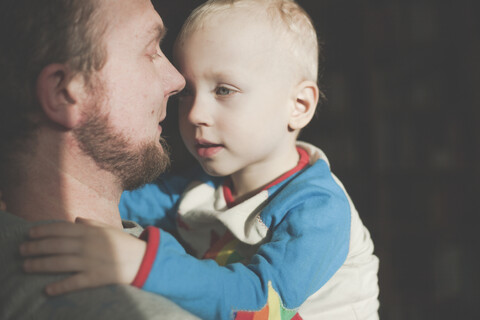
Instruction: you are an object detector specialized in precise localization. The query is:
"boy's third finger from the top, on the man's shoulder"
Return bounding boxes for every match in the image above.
[23,255,85,273]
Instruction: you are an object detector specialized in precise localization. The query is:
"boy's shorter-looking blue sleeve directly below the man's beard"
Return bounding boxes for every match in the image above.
[119,168,201,230]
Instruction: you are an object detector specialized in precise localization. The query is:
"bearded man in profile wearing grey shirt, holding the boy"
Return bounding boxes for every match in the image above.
[0,0,198,319]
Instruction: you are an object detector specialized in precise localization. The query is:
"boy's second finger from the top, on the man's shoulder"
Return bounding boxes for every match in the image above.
[20,238,82,257]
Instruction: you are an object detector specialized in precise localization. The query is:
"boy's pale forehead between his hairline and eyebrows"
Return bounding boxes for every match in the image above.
[177,16,294,83]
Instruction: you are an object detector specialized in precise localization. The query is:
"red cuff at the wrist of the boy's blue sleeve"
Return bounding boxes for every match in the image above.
[132,226,160,288]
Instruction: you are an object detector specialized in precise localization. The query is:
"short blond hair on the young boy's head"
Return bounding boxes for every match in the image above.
[177,0,320,82]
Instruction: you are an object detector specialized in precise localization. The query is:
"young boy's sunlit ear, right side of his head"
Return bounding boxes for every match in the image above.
[288,80,319,131]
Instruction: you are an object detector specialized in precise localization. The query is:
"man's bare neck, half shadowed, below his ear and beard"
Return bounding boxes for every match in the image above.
[4,129,122,228]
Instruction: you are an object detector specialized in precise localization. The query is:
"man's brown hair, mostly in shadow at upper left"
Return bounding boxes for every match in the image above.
[0,0,106,185]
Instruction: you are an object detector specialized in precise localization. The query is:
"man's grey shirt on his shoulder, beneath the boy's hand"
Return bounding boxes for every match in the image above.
[0,211,197,320]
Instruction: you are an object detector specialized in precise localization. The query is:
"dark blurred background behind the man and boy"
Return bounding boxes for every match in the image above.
[154,0,480,320]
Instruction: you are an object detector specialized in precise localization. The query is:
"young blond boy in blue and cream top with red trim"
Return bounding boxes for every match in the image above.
[21,0,378,319]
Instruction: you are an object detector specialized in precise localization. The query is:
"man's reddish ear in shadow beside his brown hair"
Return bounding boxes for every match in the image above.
[36,63,84,129]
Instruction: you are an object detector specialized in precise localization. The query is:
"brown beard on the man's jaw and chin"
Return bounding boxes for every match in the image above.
[74,112,170,190]
